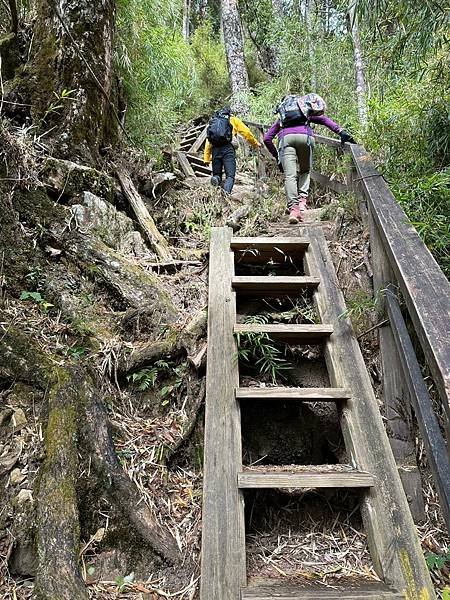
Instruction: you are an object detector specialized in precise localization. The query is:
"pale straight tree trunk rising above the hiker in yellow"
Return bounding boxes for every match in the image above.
[221,0,249,115]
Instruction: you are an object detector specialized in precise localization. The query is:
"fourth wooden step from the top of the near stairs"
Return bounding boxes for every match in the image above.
[236,387,351,402]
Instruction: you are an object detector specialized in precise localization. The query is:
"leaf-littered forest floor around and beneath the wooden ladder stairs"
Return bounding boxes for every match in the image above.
[0,134,449,600]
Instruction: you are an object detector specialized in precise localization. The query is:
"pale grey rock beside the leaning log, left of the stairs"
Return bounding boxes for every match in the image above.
[72,192,148,256]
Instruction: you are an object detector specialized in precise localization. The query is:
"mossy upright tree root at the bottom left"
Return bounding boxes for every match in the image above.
[35,370,88,600]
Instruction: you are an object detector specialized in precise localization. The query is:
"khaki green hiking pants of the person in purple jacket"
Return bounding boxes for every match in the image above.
[279,133,314,208]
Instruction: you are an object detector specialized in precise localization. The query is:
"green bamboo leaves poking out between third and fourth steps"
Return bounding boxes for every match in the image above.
[236,315,292,383]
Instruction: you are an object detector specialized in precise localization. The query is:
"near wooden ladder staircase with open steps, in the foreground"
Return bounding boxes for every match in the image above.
[200,227,435,600]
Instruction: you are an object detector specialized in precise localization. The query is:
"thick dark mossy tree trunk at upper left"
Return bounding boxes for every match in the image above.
[26,0,118,159]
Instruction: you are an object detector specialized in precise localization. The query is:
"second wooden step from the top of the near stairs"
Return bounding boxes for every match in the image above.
[231,275,320,298]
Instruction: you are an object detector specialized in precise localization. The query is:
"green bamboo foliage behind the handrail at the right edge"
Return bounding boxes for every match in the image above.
[367,63,450,275]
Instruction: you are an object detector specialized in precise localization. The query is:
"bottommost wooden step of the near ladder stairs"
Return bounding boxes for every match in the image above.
[241,582,404,600]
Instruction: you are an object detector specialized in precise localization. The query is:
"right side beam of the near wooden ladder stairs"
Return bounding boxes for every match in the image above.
[305,229,436,600]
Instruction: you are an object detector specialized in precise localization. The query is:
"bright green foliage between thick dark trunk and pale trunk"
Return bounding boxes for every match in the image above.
[116,0,228,153]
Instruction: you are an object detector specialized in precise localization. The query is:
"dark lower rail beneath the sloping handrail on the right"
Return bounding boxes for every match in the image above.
[386,291,450,532]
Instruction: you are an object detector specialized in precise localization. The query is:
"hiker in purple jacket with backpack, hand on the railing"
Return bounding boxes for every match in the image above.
[264,94,355,224]
